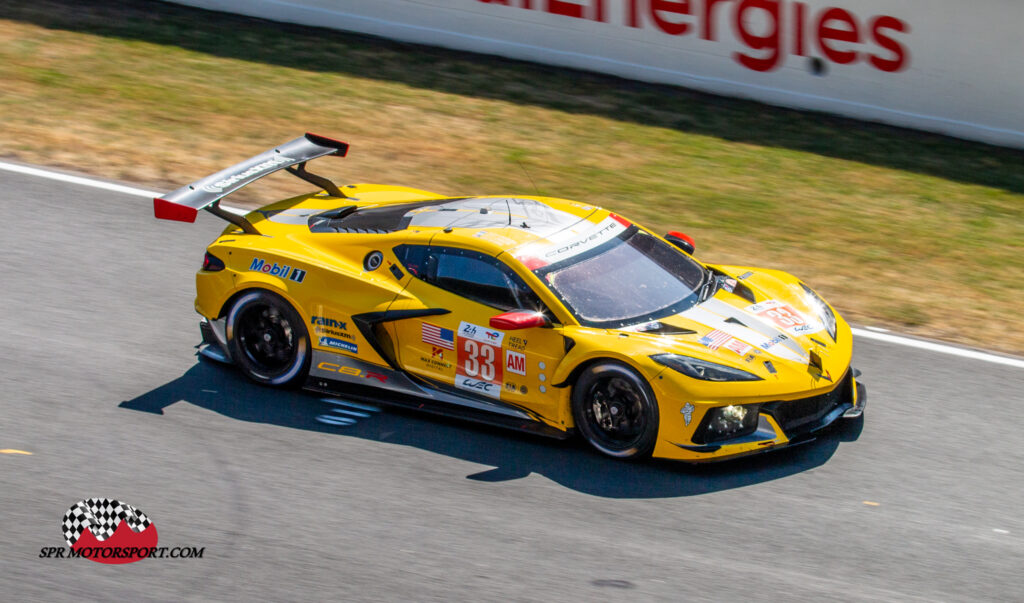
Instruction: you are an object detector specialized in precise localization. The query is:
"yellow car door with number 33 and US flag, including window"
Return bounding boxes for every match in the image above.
[390,245,565,428]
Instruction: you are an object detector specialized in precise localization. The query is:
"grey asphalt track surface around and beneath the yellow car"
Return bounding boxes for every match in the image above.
[0,165,1024,601]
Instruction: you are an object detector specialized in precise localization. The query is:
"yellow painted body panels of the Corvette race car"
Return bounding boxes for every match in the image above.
[196,184,856,462]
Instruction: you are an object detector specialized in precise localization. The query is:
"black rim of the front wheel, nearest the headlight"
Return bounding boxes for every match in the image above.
[584,377,648,450]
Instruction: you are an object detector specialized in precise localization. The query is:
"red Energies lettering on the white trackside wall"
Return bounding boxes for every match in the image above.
[477,0,910,72]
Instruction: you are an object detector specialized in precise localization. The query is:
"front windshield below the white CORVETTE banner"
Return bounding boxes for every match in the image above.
[535,226,707,328]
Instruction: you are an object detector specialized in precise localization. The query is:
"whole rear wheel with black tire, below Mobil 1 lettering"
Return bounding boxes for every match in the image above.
[226,290,312,387]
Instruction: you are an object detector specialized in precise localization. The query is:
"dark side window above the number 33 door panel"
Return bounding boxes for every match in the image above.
[394,245,546,311]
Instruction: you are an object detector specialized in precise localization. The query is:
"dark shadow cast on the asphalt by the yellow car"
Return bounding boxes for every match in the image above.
[120,361,862,499]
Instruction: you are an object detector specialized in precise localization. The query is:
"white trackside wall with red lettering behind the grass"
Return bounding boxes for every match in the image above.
[169,0,1024,147]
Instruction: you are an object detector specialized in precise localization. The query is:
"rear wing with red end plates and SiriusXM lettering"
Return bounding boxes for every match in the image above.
[153,133,348,234]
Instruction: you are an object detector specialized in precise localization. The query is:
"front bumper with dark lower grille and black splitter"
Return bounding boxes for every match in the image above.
[653,369,867,463]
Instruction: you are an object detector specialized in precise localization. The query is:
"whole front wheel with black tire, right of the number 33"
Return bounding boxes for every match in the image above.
[572,361,658,459]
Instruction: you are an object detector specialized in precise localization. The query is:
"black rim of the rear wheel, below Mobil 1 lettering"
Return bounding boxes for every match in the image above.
[238,304,297,375]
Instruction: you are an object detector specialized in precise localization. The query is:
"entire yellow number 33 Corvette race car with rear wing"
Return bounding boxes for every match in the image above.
[154,134,865,462]
